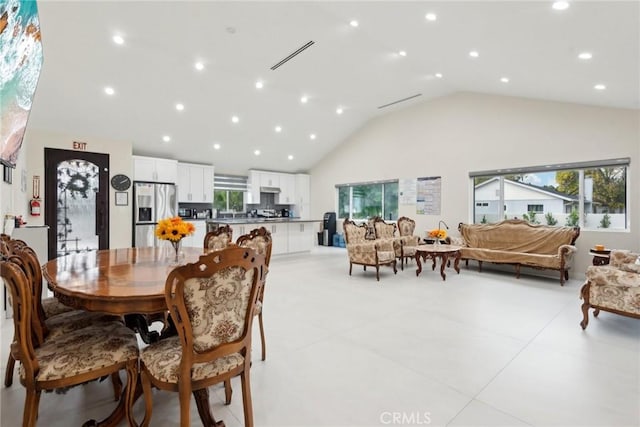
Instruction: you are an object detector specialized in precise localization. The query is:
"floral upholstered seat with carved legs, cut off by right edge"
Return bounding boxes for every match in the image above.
[580,250,640,329]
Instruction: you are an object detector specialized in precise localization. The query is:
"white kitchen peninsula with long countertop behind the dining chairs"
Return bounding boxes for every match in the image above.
[207,217,322,255]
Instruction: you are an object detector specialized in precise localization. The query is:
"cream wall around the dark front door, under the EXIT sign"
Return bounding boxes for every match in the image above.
[24,130,133,248]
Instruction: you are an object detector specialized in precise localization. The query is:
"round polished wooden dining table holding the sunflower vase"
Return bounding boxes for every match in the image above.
[42,245,224,426]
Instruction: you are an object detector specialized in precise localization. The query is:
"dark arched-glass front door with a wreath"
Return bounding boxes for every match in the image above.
[44,148,109,259]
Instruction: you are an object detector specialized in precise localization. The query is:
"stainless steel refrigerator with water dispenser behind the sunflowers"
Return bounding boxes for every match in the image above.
[133,182,178,248]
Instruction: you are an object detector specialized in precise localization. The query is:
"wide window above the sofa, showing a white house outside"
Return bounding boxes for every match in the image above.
[469,158,629,230]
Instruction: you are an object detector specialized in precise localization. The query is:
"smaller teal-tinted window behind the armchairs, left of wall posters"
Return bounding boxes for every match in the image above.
[337,181,398,220]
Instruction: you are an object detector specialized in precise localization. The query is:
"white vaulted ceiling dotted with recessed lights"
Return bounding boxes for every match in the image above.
[29,0,640,174]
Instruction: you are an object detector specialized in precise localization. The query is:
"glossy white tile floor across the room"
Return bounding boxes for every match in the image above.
[0,248,640,427]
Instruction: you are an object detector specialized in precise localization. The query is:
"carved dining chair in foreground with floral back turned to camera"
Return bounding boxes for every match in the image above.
[140,244,266,427]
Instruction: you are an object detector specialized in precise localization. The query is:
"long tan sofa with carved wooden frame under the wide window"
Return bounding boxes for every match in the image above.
[458,219,580,285]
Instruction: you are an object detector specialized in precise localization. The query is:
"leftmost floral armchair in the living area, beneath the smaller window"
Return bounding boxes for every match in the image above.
[343,219,398,281]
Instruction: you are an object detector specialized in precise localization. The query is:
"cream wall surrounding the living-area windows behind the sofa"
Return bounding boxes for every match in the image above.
[311,93,640,277]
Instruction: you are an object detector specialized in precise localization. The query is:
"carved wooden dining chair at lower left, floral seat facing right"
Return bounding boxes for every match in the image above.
[0,256,138,427]
